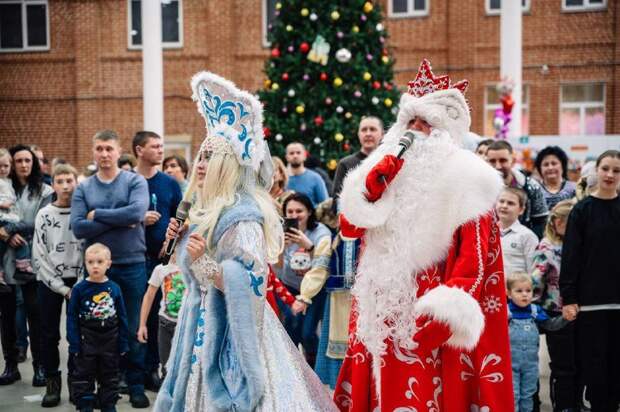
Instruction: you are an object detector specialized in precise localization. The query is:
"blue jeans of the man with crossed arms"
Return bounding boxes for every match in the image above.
[107,262,146,393]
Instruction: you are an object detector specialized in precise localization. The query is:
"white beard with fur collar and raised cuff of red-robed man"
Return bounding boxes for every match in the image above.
[341,126,502,356]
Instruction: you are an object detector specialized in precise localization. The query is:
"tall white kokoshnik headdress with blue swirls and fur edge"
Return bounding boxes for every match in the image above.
[192,72,266,171]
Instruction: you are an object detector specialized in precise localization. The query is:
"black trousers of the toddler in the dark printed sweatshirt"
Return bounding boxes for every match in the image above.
[71,319,120,408]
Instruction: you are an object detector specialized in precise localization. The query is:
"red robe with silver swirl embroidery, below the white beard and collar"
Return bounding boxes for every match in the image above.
[334,212,514,412]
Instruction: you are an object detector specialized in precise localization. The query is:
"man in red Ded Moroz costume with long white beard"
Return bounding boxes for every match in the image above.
[334,60,514,412]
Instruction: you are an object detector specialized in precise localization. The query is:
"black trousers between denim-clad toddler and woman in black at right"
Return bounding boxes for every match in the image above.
[545,313,583,411]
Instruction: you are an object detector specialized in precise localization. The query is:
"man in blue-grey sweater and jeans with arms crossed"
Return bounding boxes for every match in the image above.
[71,130,149,408]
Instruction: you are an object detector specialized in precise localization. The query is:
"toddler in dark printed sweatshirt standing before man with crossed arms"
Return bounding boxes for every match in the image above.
[67,243,129,412]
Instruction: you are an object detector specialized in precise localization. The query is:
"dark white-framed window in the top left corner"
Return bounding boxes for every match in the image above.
[0,0,50,52]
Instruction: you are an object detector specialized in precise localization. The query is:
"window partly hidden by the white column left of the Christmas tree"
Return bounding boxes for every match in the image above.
[127,0,183,49]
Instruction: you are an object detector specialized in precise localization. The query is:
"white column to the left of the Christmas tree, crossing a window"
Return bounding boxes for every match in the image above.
[141,0,164,137]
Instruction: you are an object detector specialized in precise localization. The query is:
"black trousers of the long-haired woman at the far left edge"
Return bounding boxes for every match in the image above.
[0,282,41,366]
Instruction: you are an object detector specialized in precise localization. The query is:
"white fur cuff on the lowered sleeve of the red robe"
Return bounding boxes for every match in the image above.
[415,285,484,350]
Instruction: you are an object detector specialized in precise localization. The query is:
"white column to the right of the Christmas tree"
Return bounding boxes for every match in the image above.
[500,0,523,138]
